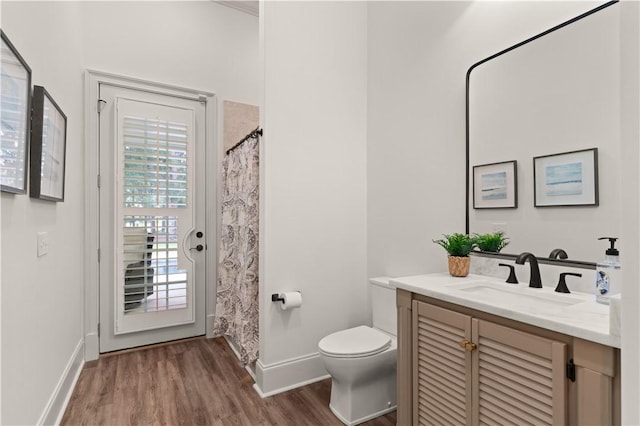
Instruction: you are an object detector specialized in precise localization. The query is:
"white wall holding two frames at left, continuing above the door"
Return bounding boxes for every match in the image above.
[0,1,261,424]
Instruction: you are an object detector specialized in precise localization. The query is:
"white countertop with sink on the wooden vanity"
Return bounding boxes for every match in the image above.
[391,273,620,348]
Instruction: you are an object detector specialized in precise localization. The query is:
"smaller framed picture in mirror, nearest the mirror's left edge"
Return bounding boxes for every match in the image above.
[473,160,518,209]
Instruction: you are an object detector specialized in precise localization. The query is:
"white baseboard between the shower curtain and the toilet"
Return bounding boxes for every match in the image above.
[253,353,331,398]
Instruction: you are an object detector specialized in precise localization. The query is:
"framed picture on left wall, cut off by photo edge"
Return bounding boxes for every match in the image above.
[0,30,31,194]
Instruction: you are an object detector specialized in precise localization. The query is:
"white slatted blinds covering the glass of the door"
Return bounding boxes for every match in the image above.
[121,115,189,313]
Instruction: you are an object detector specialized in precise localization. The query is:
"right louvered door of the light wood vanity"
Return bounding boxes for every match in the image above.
[472,319,567,425]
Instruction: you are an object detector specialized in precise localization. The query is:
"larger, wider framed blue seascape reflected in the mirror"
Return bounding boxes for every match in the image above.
[533,148,598,207]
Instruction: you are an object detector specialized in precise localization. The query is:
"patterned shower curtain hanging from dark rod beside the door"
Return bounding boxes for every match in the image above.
[213,135,259,365]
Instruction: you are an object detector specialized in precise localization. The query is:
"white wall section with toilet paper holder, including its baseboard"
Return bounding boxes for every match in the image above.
[257,2,367,394]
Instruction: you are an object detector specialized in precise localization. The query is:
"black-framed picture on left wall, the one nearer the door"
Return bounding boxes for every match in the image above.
[29,86,67,201]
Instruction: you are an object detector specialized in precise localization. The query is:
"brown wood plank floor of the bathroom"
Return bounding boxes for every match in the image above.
[61,338,396,426]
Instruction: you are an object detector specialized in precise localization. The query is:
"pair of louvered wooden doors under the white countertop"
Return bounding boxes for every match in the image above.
[412,301,567,425]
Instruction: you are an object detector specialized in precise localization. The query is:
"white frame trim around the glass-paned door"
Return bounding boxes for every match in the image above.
[84,70,220,361]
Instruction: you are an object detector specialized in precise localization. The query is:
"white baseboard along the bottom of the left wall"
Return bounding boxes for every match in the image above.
[38,340,84,425]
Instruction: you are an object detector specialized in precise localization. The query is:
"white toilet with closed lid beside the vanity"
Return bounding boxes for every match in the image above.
[318,277,397,425]
